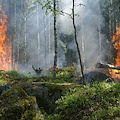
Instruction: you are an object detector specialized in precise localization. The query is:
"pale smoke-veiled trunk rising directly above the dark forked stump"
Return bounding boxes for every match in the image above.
[37,2,40,66]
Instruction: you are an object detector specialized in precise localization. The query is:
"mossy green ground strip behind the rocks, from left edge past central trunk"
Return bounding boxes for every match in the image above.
[0,67,76,85]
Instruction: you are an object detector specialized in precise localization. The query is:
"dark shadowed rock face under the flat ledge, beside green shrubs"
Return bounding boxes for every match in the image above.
[21,83,62,114]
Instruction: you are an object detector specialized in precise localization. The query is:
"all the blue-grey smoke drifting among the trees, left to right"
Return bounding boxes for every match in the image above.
[3,0,104,73]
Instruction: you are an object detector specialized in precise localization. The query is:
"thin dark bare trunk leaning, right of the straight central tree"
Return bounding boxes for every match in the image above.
[72,0,86,85]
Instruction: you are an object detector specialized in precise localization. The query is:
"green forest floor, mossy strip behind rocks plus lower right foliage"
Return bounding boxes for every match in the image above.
[0,67,120,120]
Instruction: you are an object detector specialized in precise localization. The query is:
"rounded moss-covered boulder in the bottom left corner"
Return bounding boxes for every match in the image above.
[0,87,42,120]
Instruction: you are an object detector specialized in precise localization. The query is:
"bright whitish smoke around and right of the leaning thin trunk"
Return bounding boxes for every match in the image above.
[59,0,104,67]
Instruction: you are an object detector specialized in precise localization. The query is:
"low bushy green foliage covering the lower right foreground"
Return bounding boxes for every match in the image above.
[48,83,120,120]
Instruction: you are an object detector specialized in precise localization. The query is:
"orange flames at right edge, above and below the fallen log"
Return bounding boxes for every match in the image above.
[109,23,120,79]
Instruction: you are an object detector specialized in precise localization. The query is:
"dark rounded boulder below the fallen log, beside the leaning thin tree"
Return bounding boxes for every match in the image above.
[77,71,114,84]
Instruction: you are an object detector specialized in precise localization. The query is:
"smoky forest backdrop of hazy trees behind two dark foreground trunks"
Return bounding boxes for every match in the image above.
[0,0,120,72]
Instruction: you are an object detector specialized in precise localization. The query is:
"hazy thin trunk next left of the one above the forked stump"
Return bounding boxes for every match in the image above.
[24,1,27,66]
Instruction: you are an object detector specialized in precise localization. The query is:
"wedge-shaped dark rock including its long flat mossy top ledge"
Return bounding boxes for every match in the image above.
[16,82,81,114]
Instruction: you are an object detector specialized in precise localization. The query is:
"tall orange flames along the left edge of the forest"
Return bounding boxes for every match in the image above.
[0,5,11,70]
